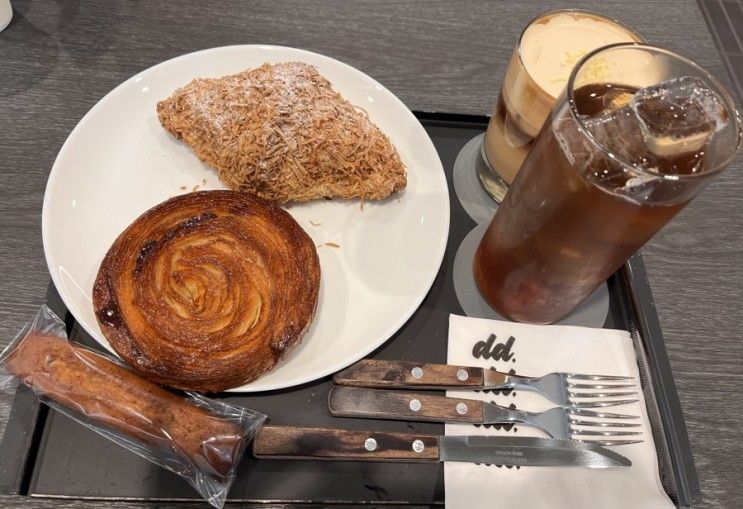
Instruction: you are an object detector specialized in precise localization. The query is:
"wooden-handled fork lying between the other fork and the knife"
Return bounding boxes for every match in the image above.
[328,386,642,446]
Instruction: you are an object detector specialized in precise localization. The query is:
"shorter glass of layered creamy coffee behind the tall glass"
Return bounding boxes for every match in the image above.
[477,9,643,203]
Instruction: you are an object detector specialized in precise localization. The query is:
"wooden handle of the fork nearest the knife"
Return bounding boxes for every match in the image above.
[328,386,483,424]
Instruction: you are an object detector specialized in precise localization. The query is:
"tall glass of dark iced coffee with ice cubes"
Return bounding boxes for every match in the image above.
[474,44,741,323]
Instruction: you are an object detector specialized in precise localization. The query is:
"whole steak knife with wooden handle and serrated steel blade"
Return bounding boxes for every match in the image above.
[253,426,632,468]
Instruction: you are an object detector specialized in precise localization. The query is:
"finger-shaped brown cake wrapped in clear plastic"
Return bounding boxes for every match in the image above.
[0,306,266,508]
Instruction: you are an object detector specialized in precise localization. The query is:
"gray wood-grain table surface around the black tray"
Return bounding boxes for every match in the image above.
[0,0,743,508]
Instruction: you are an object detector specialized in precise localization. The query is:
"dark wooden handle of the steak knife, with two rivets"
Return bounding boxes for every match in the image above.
[253,426,439,463]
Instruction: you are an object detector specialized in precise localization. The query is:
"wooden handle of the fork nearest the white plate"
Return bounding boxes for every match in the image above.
[333,359,483,389]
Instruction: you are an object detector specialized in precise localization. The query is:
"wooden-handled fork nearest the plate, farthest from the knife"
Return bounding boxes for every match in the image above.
[333,359,638,408]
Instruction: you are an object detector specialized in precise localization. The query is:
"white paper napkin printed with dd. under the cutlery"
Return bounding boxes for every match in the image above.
[444,315,674,509]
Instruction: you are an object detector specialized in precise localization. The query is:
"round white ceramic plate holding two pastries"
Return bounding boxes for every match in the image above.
[42,46,449,392]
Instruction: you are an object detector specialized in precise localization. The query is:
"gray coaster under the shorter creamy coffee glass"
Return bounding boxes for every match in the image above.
[453,133,498,224]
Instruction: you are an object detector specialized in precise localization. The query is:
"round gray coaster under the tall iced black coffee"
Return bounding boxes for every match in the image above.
[452,224,609,327]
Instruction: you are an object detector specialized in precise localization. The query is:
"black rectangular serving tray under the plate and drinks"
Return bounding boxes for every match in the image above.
[0,113,701,507]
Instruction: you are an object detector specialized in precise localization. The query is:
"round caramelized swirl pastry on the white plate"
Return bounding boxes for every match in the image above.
[93,191,320,392]
